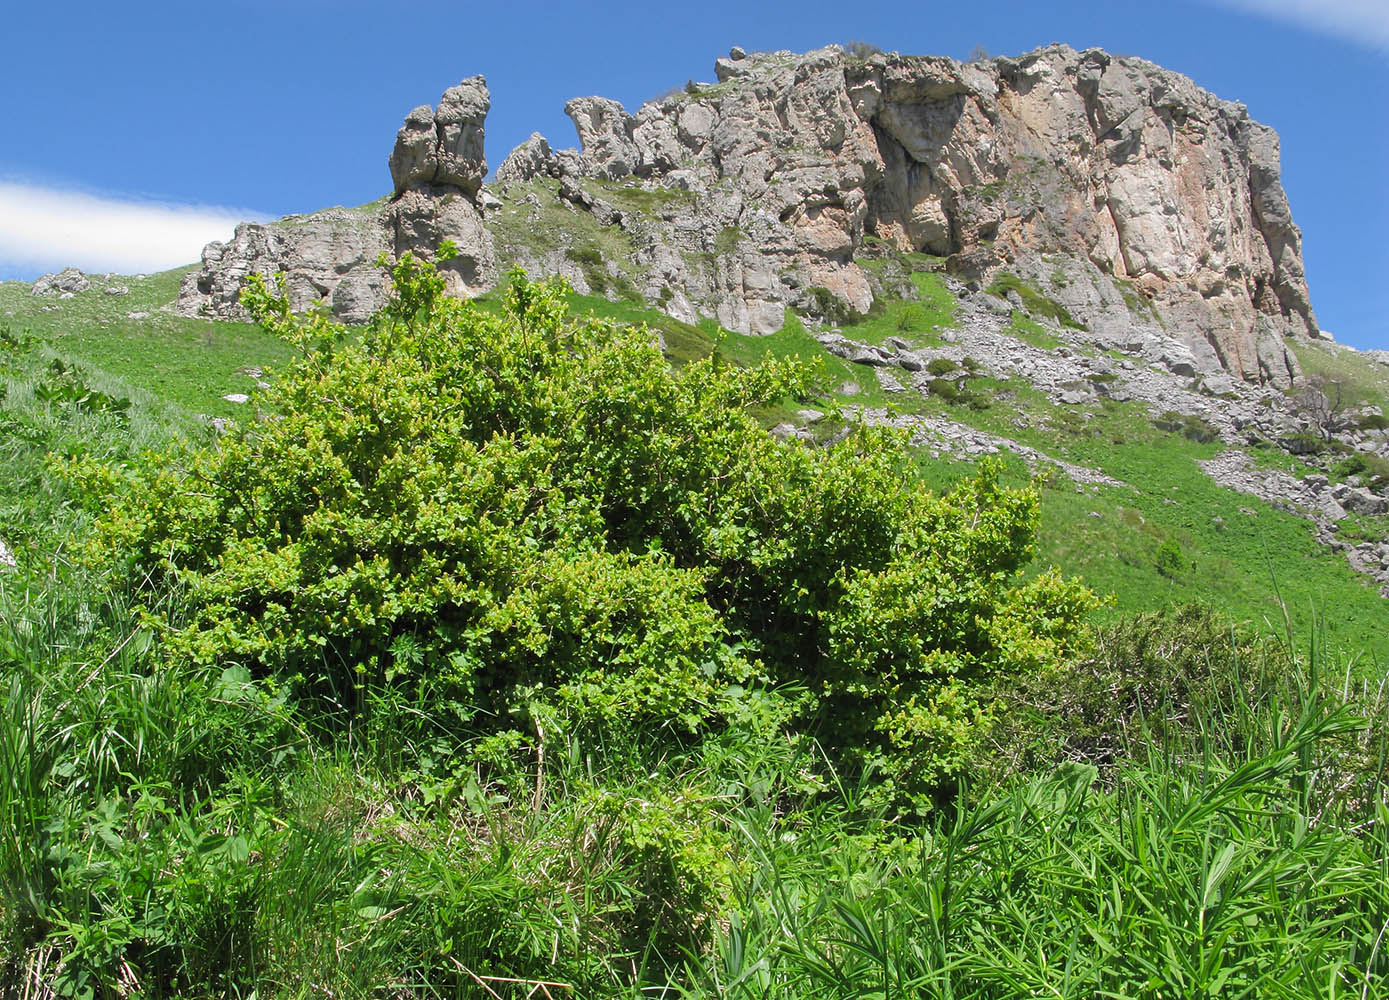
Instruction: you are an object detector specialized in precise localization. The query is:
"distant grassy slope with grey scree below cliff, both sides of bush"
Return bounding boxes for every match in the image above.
[0,249,1389,663]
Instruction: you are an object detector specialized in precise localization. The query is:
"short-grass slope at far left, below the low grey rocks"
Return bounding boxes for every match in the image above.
[0,268,289,417]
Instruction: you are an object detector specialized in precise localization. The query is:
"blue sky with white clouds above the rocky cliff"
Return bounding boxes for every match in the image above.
[0,0,1389,349]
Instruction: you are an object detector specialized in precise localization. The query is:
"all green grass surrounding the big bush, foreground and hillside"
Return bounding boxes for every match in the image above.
[0,261,1389,1000]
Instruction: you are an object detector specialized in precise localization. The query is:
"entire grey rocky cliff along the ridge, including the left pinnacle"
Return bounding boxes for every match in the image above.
[179,46,1317,386]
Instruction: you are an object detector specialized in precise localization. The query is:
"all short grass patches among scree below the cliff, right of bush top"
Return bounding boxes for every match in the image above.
[547,284,1389,672]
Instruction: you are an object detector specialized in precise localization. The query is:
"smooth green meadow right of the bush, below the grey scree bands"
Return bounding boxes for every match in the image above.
[911,391,1389,664]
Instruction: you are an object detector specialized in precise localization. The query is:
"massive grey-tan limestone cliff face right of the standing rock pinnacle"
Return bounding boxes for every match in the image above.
[497,46,1317,385]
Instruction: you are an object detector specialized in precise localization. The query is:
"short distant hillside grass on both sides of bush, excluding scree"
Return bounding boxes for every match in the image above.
[0,269,1389,664]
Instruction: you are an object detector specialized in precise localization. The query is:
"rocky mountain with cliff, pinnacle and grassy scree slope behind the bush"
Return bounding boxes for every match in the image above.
[152,46,1389,643]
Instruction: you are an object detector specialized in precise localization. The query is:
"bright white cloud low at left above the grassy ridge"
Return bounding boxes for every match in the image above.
[0,179,257,276]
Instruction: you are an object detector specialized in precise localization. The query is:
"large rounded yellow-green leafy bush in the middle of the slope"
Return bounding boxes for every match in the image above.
[71,249,1095,799]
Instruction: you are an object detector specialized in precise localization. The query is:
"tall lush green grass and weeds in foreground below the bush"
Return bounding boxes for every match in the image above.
[0,558,1389,1000]
